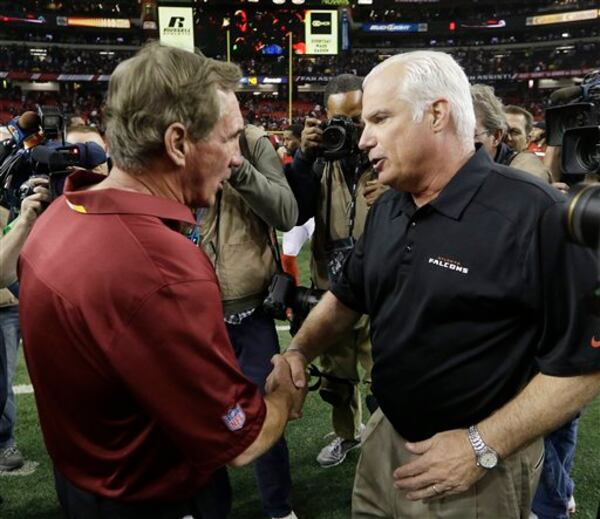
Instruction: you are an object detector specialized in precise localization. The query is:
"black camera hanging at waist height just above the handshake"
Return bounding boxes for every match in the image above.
[263,272,325,329]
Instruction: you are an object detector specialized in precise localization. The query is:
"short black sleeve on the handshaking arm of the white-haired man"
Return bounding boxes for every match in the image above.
[330,218,369,314]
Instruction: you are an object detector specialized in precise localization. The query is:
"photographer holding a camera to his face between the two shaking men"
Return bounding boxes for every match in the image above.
[287,74,383,467]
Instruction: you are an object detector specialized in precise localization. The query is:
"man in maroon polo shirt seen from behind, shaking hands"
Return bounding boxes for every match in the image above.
[20,44,302,519]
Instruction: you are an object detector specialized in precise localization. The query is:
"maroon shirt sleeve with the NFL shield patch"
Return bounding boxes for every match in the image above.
[107,280,266,470]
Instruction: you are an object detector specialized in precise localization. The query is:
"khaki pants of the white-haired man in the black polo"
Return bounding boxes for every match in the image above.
[352,409,544,519]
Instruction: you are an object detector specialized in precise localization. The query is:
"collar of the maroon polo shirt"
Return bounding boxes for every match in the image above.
[64,170,196,225]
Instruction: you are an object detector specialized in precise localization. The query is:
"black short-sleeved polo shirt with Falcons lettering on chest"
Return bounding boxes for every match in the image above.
[332,149,600,441]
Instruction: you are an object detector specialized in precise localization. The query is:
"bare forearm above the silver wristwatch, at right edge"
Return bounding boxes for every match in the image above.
[478,373,600,458]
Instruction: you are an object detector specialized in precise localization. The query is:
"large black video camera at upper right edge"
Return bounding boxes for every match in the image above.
[546,70,600,179]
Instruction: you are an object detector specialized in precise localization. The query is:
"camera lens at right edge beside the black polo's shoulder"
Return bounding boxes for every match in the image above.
[566,184,600,248]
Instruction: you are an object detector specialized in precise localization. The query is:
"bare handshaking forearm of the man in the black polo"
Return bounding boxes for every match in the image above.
[288,292,361,362]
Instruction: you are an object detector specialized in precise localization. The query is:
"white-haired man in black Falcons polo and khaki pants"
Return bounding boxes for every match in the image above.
[276,52,600,519]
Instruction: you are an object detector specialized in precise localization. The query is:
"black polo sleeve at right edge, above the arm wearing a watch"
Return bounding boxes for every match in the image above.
[537,202,600,376]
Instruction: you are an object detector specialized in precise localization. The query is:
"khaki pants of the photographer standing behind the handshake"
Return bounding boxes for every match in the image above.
[320,316,373,440]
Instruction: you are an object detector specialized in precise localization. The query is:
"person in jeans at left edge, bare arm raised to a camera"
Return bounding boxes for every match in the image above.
[0,178,50,472]
